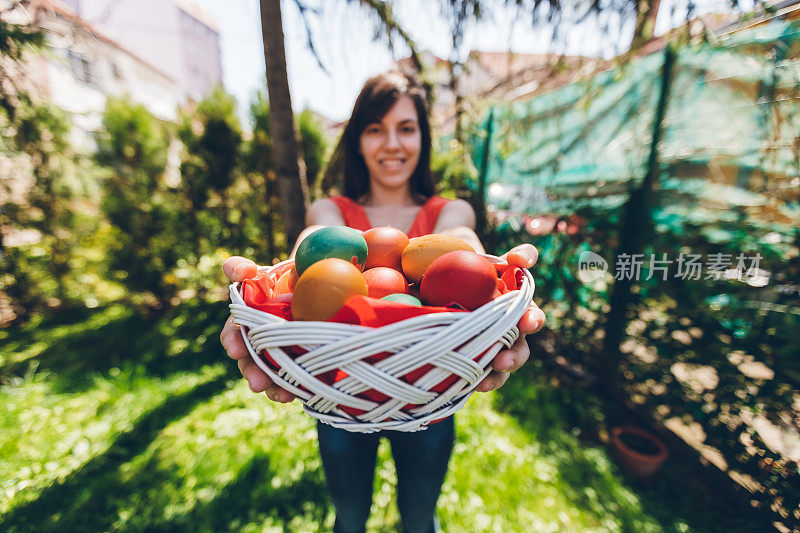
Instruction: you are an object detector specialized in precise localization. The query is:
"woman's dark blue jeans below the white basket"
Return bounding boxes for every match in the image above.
[317,416,455,533]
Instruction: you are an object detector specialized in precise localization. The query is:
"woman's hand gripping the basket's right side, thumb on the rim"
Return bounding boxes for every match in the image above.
[475,244,545,392]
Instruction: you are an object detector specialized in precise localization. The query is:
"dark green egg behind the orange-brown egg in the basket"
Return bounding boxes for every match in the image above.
[294,226,367,275]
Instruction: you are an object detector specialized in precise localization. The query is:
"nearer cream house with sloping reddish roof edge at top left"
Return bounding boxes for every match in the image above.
[10,0,185,151]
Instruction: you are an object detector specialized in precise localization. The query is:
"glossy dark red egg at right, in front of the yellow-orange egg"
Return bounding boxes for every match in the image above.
[420,250,497,311]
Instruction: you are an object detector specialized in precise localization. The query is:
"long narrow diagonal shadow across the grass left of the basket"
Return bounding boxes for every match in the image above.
[0,376,229,531]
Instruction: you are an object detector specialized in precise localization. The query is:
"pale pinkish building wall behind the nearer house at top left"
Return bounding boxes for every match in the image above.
[62,0,222,101]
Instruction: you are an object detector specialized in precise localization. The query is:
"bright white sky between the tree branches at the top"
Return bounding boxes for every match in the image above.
[195,0,744,125]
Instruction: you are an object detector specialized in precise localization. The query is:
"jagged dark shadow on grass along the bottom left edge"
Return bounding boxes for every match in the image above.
[2,455,329,532]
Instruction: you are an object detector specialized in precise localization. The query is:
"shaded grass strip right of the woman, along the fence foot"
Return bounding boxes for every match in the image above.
[496,354,764,532]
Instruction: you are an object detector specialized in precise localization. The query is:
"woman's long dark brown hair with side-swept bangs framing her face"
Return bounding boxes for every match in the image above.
[337,71,435,204]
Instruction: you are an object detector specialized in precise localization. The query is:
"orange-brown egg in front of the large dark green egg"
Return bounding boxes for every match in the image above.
[292,257,367,320]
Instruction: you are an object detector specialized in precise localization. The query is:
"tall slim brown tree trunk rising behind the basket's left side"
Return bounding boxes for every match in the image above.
[260,0,306,251]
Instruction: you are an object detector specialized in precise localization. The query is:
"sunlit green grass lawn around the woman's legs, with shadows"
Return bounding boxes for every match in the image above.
[0,303,764,532]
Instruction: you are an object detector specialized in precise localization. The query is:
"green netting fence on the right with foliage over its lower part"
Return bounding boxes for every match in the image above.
[468,15,800,527]
